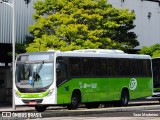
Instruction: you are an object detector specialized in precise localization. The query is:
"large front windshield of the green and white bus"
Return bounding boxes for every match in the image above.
[16,61,53,88]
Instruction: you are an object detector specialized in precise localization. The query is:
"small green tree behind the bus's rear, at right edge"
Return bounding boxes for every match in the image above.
[139,44,160,58]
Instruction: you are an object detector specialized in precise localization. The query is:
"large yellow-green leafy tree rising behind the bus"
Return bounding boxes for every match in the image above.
[26,0,139,52]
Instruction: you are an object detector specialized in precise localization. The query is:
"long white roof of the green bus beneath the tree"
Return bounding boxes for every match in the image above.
[17,49,151,59]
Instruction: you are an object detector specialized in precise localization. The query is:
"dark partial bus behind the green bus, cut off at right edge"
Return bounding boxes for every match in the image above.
[151,58,160,102]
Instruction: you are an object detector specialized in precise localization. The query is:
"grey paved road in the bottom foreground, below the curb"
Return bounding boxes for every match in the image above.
[33,109,160,120]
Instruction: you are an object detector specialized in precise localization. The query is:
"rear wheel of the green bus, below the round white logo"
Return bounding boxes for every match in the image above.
[120,90,129,106]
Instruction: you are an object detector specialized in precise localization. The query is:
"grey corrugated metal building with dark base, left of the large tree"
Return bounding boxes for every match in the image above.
[0,0,36,105]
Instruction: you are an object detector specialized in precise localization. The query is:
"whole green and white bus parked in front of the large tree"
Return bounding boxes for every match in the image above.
[13,49,153,112]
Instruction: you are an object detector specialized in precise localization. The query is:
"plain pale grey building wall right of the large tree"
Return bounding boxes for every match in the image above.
[107,0,160,49]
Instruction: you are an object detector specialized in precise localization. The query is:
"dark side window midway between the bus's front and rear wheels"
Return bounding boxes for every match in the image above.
[95,58,107,76]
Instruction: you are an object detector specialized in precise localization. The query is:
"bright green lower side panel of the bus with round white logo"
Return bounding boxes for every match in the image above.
[57,78,152,104]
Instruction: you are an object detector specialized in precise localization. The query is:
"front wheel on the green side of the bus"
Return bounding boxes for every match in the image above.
[67,91,81,110]
